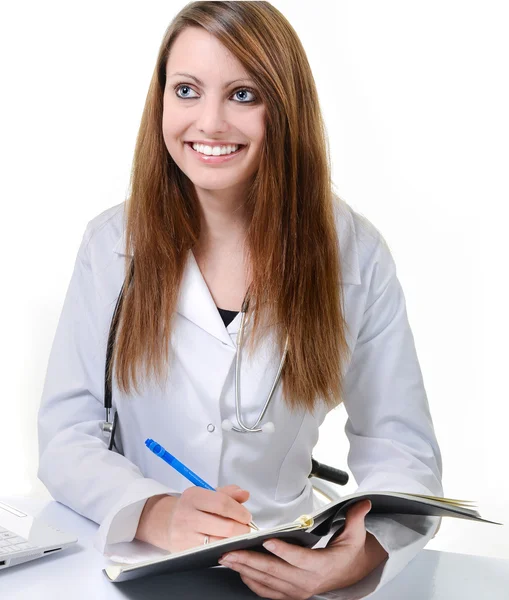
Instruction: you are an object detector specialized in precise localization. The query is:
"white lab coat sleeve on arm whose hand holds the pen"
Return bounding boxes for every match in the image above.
[38,227,178,552]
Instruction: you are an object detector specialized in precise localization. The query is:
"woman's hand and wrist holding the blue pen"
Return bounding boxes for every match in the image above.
[136,485,252,552]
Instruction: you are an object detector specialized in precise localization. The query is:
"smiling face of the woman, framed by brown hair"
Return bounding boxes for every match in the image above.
[163,27,265,197]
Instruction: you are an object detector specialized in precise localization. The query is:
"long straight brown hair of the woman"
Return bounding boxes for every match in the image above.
[110,1,348,410]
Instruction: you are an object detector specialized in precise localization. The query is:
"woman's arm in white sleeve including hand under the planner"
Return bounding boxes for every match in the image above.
[208,230,443,600]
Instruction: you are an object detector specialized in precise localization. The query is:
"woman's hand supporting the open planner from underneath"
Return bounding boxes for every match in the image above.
[219,500,388,600]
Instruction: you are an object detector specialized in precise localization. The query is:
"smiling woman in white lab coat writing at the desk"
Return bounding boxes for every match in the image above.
[39,2,442,598]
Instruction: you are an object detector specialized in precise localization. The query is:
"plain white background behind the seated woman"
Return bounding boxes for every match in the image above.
[0,0,509,558]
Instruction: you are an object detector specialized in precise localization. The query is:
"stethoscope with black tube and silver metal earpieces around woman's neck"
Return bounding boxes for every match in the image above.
[101,260,288,451]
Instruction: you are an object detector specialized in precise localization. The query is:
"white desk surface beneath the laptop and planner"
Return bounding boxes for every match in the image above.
[0,496,509,600]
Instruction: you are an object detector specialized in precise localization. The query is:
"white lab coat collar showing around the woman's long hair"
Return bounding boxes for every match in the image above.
[113,210,361,348]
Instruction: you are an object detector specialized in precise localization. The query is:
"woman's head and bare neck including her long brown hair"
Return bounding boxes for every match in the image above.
[112,2,349,409]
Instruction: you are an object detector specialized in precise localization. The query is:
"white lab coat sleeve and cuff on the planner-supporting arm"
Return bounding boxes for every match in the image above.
[334,231,443,591]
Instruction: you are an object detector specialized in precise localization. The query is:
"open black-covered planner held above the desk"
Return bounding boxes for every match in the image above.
[103,491,502,583]
